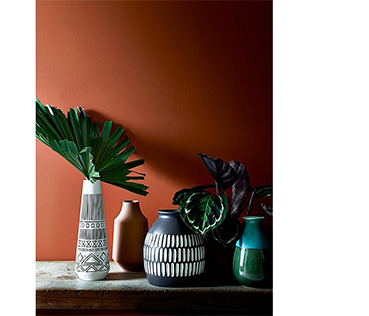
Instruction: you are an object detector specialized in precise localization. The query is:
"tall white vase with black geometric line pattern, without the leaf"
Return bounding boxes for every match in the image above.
[75,180,110,281]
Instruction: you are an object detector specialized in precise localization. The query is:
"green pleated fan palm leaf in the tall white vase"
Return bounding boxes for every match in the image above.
[36,99,148,195]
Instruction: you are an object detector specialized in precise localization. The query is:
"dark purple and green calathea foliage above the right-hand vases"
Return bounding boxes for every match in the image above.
[173,153,271,247]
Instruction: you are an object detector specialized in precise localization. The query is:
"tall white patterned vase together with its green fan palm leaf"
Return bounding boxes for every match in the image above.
[36,98,148,280]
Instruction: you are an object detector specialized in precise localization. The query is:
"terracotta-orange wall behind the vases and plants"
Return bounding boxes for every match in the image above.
[36,1,272,260]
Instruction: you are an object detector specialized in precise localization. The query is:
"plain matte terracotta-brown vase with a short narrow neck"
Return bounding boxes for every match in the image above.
[113,200,148,272]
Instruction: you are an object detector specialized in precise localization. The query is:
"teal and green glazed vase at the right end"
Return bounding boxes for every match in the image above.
[233,216,273,288]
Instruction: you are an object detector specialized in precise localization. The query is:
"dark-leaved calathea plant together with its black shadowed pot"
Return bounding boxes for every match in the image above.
[173,153,272,282]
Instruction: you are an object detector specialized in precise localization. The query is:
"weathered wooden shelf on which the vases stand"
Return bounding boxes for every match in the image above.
[36,261,272,315]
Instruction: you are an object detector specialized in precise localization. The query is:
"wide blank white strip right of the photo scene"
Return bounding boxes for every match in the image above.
[273,0,369,316]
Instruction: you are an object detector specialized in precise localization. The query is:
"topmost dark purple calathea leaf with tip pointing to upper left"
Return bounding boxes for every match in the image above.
[199,153,238,190]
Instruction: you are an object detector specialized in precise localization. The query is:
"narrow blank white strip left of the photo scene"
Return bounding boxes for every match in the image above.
[0,0,36,315]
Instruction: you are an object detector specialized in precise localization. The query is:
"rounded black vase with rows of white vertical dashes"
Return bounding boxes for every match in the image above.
[143,210,205,287]
